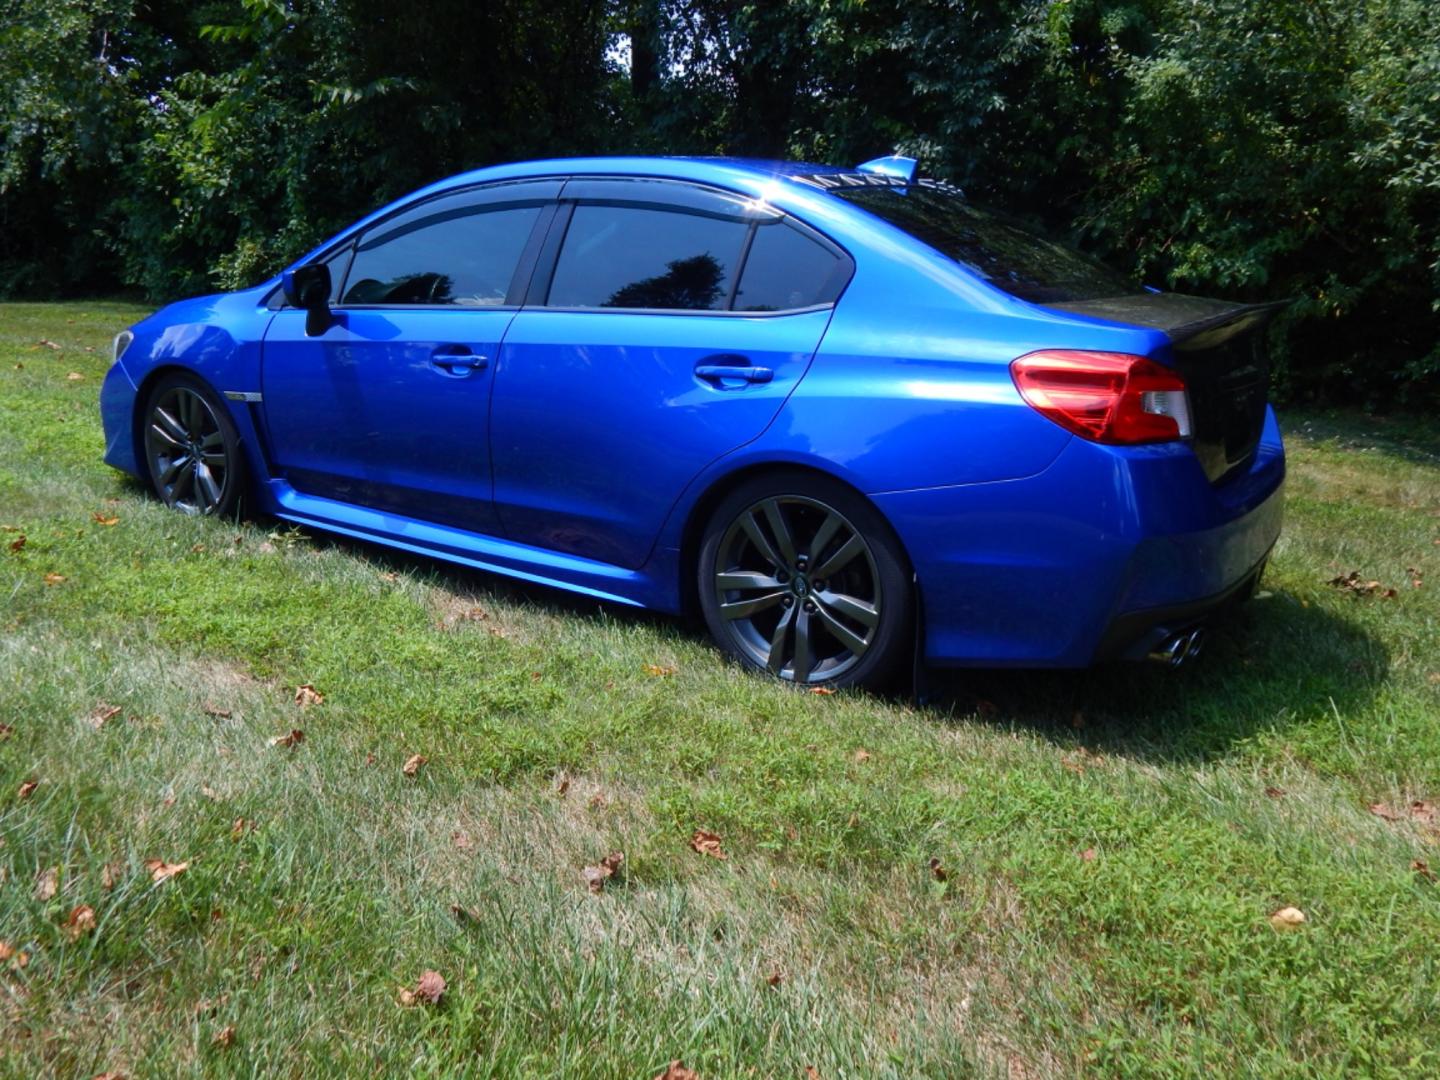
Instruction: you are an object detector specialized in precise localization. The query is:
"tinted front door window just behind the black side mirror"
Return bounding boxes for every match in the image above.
[344,196,540,307]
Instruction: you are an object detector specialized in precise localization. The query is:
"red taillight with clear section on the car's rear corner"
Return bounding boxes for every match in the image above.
[1009,348,1189,444]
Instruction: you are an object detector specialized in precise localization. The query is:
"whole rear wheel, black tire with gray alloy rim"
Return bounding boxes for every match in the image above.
[696,471,914,690]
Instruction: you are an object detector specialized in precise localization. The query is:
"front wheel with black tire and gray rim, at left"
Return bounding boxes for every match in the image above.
[140,374,248,517]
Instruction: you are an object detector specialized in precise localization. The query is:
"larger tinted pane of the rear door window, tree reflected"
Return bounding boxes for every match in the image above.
[549,206,749,311]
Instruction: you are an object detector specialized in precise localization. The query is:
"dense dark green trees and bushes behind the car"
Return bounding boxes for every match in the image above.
[0,0,1440,406]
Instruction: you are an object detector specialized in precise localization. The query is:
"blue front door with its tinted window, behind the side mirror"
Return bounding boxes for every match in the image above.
[262,181,560,533]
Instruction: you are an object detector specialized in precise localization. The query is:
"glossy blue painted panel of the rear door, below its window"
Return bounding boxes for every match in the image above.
[491,310,831,567]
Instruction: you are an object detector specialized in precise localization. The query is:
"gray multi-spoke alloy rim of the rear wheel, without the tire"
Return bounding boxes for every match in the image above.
[713,495,886,683]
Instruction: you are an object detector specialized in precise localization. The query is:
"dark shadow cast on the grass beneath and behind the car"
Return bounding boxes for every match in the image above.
[247,520,1390,762]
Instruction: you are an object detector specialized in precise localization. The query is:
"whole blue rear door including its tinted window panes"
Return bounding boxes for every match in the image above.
[491,180,851,567]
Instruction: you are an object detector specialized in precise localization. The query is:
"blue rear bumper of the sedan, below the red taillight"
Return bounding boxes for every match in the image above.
[873,412,1284,667]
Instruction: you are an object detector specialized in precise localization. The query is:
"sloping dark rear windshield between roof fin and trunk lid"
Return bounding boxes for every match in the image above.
[829,180,1142,304]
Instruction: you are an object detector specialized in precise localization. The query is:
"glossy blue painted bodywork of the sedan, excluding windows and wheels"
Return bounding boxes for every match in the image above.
[101,158,1284,667]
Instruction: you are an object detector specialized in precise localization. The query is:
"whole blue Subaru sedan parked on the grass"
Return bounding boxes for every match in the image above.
[101,157,1284,685]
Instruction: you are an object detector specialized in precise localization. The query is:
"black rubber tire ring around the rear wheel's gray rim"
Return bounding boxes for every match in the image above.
[696,471,914,690]
